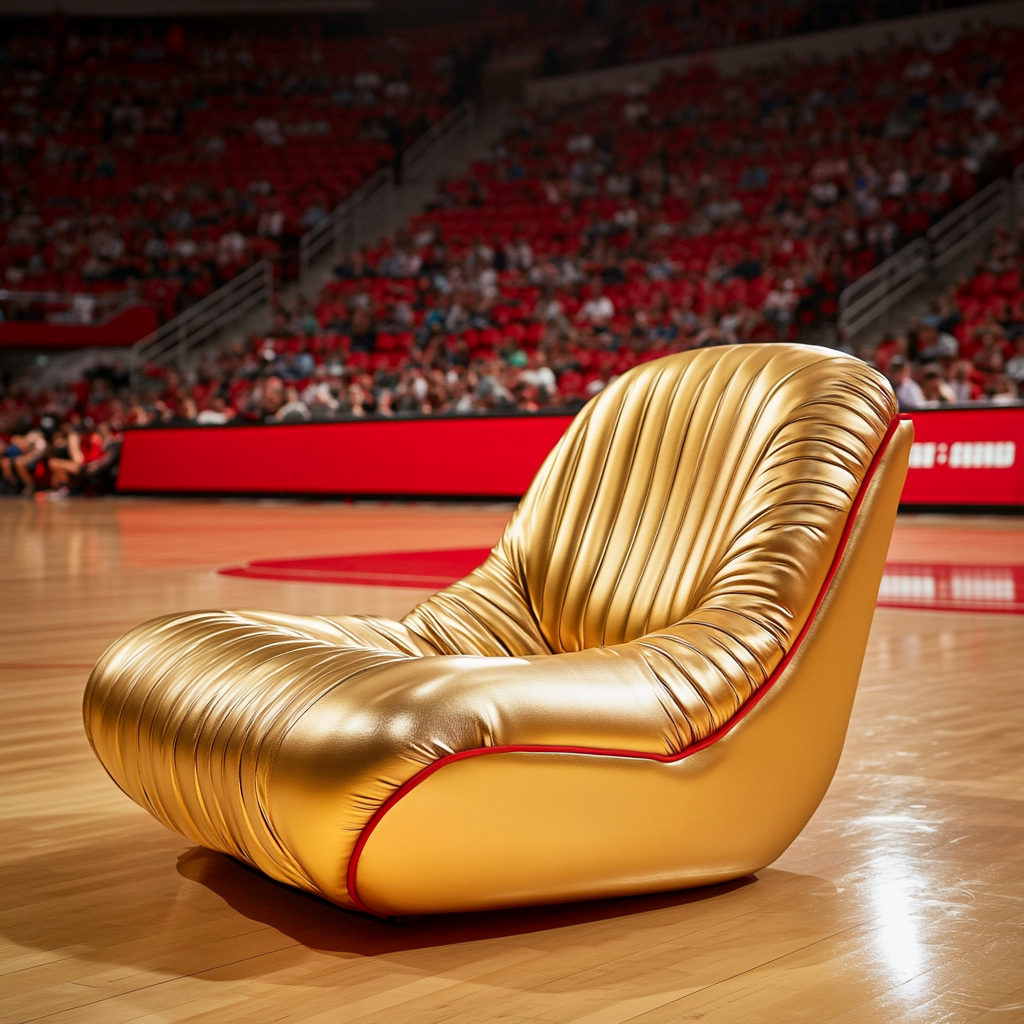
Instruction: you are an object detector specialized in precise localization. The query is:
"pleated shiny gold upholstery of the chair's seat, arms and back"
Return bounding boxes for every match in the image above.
[85,345,895,905]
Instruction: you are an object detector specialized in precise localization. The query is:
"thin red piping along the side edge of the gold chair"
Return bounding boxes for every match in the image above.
[346,416,909,918]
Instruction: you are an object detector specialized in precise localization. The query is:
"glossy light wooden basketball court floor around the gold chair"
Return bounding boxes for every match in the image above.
[0,500,1024,1024]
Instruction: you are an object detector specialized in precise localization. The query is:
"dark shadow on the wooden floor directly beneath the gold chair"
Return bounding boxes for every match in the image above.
[177,847,757,956]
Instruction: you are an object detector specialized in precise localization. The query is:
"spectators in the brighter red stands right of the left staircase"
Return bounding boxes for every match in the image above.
[0,16,1024,494]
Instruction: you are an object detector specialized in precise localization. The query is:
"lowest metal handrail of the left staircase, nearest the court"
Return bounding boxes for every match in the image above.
[129,260,273,387]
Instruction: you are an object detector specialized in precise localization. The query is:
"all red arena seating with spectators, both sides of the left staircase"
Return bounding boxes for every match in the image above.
[0,14,1024,495]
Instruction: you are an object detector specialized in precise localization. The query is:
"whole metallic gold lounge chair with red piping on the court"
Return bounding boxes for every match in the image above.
[85,345,912,914]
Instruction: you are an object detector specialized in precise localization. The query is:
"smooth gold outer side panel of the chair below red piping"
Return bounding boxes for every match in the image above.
[354,423,913,914]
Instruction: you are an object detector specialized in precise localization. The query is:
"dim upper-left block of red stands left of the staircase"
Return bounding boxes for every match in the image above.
[0,18,489,318]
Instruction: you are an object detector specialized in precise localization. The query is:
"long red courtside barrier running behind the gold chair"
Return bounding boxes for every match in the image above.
[118,407,1024,507]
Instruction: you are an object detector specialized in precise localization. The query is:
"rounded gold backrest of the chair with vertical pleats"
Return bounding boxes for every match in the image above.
[406,345,896,663]
